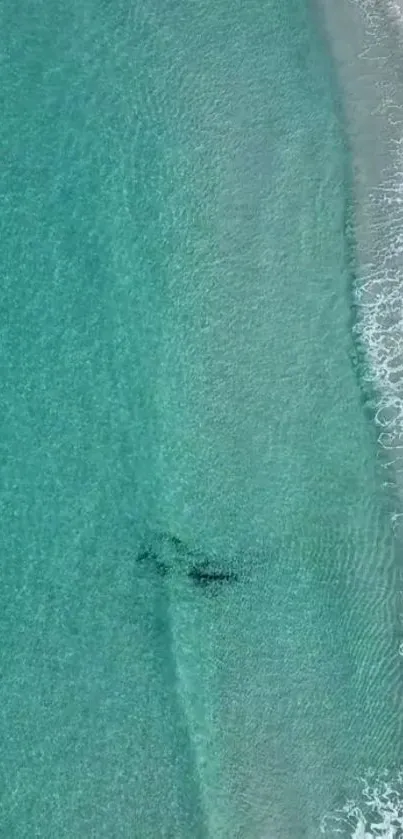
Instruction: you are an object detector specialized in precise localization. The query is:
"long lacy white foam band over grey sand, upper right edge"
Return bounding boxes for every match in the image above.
[355,0,403,521]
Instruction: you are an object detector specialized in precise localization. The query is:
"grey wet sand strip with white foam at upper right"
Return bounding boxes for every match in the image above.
[316,0,403,524]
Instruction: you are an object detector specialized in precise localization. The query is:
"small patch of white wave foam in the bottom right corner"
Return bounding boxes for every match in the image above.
[320,773,403,839]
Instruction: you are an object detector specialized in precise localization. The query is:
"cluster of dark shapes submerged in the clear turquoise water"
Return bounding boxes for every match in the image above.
[137,533,239,589]
